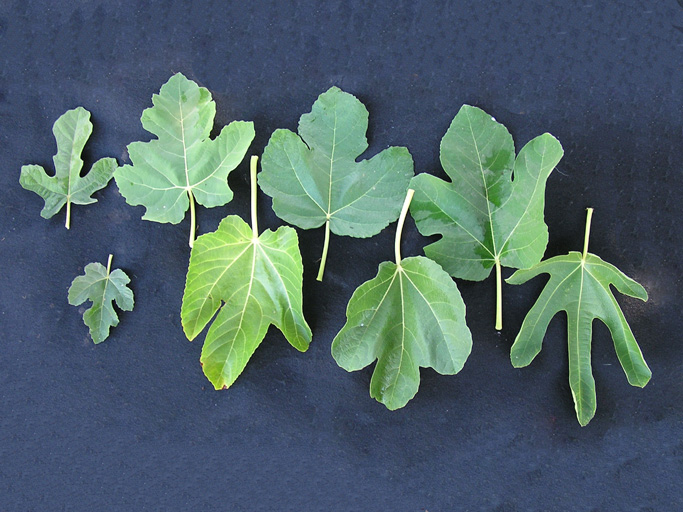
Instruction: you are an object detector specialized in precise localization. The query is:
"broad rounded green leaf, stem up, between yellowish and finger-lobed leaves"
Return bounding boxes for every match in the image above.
[332,190,472,410]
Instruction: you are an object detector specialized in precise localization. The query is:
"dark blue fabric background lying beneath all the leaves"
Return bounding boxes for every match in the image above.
[0,0,683,512]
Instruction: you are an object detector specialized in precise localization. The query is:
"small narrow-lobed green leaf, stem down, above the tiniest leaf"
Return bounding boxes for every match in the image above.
[19,107,116,229]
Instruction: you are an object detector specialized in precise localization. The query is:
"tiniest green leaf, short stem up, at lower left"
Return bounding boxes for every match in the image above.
[69,255,133,343]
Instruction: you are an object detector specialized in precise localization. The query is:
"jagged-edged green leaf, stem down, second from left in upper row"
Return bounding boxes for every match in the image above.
[114,73,254,246]
